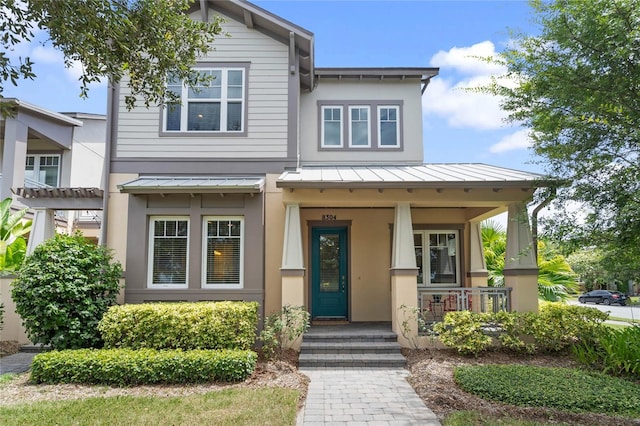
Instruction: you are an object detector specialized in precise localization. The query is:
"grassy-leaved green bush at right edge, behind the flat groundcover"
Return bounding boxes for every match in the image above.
[573,326,640,378]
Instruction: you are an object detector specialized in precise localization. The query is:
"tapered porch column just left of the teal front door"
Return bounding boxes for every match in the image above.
[280,204,305,306]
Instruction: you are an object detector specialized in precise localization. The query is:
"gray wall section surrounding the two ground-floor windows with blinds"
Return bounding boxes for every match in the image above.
[125,194,264,305]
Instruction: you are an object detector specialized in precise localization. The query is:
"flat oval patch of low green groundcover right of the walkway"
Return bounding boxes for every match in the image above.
[454,365,640,417]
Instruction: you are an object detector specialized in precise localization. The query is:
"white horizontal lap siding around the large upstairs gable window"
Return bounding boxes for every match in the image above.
[116,10,289,158]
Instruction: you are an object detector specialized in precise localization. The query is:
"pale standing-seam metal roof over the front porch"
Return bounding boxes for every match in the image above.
[276,163,547,190]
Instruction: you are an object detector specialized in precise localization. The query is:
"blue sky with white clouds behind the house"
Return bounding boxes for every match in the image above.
[4,0,541,172]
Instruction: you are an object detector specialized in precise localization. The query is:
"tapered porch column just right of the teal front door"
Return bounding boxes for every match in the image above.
[391,203,418,347]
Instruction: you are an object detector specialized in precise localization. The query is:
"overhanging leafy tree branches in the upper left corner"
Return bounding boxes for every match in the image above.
[0,0,222,112]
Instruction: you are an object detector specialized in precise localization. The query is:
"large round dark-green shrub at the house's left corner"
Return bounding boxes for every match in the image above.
[11,234,122,349]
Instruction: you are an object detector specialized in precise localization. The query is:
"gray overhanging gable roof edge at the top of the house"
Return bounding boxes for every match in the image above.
[192,0,315,90]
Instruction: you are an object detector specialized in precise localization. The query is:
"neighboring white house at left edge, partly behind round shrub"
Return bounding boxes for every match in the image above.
[0,98,107,343]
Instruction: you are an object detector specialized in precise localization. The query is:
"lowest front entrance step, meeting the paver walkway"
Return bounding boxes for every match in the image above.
[298,352,406,368]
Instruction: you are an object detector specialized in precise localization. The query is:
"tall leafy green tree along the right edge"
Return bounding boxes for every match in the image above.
[485,0,640,276]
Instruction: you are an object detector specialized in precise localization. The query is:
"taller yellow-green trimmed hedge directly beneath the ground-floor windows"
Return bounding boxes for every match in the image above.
[98,302,258,350]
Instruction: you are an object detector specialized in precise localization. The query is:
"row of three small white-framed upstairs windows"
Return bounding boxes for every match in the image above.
[318,101,402,150]
